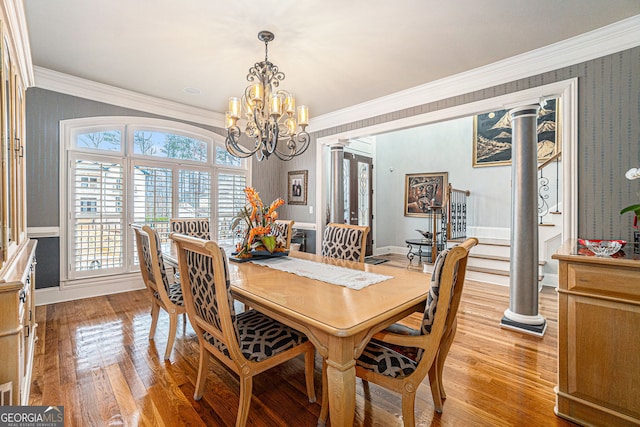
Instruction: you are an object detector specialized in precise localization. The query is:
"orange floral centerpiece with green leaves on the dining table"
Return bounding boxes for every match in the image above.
[231,187,286,258]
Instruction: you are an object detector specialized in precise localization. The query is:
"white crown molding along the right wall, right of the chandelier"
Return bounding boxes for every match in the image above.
[308,15,640,132]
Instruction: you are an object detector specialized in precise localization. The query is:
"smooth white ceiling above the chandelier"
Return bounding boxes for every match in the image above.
[24,0,640,117]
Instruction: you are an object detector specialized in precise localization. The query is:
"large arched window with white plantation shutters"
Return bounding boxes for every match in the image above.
[60,117,250,281]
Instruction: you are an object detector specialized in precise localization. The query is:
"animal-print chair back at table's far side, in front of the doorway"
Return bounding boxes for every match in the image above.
[322,223,369,262]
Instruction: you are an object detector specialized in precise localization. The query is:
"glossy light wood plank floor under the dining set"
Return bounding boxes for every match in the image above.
[31,255,573,427]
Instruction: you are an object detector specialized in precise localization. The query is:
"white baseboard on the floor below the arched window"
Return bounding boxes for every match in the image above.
[36,273,144,306]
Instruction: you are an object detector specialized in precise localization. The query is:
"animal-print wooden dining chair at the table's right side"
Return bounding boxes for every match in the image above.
[321,237,478,427]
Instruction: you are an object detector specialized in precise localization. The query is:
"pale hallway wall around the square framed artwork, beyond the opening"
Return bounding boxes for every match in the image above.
[374,117,511,248]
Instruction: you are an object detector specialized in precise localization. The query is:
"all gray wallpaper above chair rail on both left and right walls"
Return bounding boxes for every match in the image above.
[26,47,640,290]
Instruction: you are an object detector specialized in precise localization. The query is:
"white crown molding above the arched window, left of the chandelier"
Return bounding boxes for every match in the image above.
[34,66,224,128]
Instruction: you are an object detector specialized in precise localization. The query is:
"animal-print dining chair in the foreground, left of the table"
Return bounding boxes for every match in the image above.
[170,233,316,427]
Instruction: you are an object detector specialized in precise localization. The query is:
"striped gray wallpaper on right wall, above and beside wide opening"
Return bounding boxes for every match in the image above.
[288,47,640,244]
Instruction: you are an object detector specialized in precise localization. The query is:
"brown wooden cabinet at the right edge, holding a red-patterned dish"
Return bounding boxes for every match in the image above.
[553,241,640,426]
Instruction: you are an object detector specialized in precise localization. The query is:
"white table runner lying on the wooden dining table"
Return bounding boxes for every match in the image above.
[251,257,393,290]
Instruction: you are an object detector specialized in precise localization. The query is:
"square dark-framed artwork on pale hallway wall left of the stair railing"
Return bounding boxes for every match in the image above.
[404,172,449,217]
